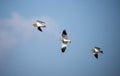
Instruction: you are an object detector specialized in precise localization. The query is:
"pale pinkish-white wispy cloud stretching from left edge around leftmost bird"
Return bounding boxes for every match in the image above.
[0,12,60,50]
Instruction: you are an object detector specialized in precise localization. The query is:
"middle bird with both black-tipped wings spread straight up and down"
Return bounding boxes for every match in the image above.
[61,29,71,53]
